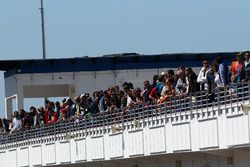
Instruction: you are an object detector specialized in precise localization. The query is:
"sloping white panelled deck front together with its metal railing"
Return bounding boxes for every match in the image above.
[0,83,250,167]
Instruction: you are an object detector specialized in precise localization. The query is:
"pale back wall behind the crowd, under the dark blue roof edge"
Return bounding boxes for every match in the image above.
[5,68,199,98]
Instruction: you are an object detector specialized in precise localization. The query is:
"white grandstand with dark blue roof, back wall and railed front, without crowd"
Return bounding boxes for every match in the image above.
[0,53,250,167]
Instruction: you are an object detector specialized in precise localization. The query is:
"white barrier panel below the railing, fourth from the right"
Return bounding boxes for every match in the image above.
[147,126,166,154]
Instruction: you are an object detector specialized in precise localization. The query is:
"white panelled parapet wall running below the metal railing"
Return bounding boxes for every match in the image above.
[0,101,250,167]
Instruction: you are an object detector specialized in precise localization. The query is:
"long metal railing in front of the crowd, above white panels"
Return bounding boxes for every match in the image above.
[0,82,250,146]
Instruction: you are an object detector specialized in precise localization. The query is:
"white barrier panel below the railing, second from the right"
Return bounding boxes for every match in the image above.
[198,119,219,149]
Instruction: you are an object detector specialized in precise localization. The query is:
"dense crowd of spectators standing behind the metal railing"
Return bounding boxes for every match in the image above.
[0,51,250,136]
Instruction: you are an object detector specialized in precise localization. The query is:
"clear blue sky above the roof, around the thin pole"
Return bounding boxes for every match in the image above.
[0,0,250,116]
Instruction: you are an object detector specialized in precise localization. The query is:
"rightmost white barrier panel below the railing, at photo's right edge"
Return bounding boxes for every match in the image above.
[227,115,249,146]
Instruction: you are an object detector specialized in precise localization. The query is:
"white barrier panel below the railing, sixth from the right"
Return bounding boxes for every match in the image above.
[109,133,124,159]
